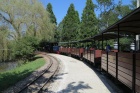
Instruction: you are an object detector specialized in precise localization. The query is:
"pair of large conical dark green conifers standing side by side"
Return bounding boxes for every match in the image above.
[58,0,98,42]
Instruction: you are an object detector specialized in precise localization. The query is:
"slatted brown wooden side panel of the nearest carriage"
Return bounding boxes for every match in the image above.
[101,52,140,93]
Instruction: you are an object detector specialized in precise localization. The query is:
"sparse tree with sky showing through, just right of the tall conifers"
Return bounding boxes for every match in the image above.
[97,0,118,31]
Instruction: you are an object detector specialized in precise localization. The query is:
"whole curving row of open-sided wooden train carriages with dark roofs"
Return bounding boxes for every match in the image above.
[60,8,140,93]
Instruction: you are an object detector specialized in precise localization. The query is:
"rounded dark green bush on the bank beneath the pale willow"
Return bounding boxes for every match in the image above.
[13,37,39,61]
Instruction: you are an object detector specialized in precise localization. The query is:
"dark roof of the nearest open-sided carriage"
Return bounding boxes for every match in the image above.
[103,7,140,35]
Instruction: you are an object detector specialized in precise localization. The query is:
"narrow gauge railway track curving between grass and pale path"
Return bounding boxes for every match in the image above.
[18,56,59,93]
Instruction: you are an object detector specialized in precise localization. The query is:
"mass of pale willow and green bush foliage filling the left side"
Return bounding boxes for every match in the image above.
[0,0,56,61]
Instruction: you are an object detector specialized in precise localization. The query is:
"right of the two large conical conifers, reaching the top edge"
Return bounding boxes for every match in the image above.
[79,0,98,39]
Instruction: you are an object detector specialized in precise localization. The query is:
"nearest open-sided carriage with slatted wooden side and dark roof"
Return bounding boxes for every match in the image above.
[101,8,140,93]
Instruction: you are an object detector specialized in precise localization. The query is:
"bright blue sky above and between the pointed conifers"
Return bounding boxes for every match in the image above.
[39,0,131,23]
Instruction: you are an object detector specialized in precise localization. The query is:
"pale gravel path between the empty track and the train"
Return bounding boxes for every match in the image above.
[47,54,122,93]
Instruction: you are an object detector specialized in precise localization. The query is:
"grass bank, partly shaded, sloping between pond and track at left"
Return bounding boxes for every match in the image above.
[0,58,45,92]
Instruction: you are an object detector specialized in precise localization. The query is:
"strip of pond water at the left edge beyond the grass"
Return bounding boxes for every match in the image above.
[0,62,19,73]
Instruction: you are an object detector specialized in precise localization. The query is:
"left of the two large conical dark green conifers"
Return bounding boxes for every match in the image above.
[62,4,80,41]
